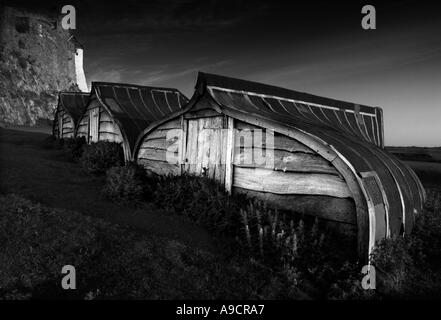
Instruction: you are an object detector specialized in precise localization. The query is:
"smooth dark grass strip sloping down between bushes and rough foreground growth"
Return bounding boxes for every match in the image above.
[0,129,217,250]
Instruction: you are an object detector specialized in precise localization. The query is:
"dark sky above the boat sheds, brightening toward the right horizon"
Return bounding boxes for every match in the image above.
[7,0,441,146]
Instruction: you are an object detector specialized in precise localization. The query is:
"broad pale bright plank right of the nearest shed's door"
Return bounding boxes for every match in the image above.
[233,166,351,198]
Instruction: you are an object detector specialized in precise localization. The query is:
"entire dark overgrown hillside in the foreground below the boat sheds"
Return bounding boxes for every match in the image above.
[0,128,441,299]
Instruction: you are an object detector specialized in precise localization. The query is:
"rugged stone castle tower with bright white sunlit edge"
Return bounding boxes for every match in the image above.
[0,6,87,125]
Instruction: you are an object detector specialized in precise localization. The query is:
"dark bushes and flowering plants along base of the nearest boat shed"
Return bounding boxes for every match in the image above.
[99,171,441,299]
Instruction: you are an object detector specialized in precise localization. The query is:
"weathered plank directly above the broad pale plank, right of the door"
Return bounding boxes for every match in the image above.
[234,148,338,175]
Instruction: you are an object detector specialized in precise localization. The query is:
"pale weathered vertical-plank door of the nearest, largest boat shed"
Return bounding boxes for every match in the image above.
[184,116,227,184]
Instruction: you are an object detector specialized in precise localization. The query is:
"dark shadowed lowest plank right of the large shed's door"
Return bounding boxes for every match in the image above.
[233,188,357,225]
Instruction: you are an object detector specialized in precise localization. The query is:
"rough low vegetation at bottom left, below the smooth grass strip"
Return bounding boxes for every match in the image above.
[0,194,283,299]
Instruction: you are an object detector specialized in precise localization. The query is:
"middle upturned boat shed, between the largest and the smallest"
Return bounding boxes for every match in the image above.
[76,82,188,161]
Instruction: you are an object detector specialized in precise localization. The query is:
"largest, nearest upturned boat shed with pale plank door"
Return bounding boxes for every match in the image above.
[134,73,425,257]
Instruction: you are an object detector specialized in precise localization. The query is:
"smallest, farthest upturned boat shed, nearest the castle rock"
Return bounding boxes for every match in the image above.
[52,91,89,139]
